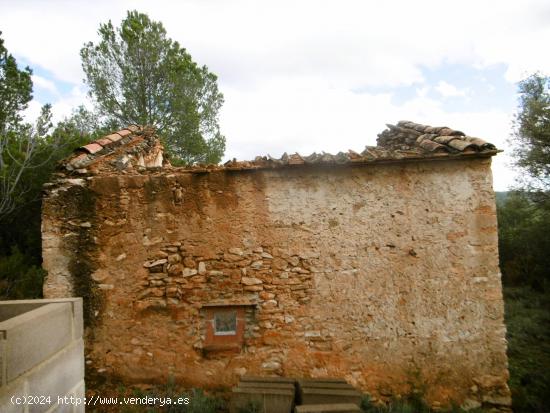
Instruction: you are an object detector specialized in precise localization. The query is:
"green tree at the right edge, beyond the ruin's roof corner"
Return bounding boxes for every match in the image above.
[514,73,550,201]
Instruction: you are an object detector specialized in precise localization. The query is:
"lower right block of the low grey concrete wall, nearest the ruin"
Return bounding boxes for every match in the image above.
[28,340,84,412]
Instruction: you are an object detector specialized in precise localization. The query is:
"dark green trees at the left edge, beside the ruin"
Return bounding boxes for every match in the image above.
[0,31,100,299]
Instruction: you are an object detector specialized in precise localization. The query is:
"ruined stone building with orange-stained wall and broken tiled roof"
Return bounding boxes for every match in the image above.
[42,121,510,410]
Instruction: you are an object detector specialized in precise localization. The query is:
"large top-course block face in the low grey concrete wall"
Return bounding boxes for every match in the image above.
[0,303,73,383]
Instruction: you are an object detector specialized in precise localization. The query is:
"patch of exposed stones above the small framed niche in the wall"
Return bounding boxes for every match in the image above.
[138,242,318,310]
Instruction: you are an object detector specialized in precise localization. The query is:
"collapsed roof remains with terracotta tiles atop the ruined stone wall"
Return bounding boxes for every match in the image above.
[62,121,499,173]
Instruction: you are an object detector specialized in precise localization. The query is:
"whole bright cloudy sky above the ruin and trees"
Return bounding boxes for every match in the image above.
[0,0,550,190]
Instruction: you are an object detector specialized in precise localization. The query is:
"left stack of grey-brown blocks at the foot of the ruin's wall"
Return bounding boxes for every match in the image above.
[229,387,294,413]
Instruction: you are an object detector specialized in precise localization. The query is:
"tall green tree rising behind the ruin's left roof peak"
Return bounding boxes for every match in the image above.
[80,11,225,164]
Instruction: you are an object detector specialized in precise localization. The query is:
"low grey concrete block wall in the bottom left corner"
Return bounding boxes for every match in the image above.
[0,298,84,413]
